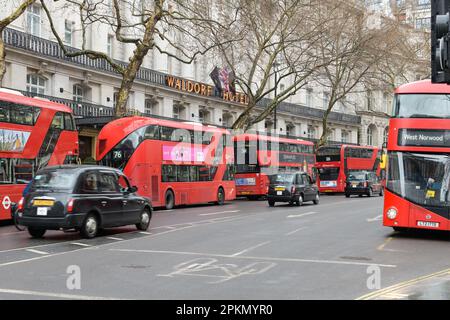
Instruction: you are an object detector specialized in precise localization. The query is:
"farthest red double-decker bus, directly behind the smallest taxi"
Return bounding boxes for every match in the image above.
[316,144,381,192]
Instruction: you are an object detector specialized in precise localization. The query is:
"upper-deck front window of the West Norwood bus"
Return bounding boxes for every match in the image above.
[393,94,450,118]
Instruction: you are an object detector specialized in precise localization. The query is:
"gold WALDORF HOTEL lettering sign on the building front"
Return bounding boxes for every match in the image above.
[166,75,248,105]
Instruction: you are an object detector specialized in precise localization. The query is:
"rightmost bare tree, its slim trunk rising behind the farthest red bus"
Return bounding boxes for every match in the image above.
[316,1,406,147]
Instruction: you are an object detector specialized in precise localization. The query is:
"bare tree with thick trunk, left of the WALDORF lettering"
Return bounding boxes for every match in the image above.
[40,0,239,117]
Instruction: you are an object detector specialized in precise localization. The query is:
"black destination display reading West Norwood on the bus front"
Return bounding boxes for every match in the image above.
[398,129,450,148]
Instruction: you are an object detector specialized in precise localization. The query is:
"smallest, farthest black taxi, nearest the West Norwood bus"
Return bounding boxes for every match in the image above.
[345,171,384,198]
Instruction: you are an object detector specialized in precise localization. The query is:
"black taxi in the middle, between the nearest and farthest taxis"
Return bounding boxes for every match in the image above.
[267,172,319,207]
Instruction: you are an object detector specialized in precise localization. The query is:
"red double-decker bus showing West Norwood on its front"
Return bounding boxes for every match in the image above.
[383,80,450,230]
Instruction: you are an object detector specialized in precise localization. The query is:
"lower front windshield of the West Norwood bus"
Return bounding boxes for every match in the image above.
[386,152,450,207]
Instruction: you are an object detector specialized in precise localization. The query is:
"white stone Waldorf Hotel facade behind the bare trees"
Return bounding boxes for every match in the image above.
[0,3,424,160]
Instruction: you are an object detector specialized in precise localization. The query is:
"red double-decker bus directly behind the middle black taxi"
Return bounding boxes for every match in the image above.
[233,133,315,199]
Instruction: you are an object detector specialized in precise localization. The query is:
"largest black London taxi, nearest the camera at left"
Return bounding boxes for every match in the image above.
[17,165,152,238]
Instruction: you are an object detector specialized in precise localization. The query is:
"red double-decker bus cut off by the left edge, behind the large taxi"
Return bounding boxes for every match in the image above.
[0,89,78,220]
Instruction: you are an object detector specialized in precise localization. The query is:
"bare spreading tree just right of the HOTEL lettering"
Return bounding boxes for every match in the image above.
[209,0,328,130]
